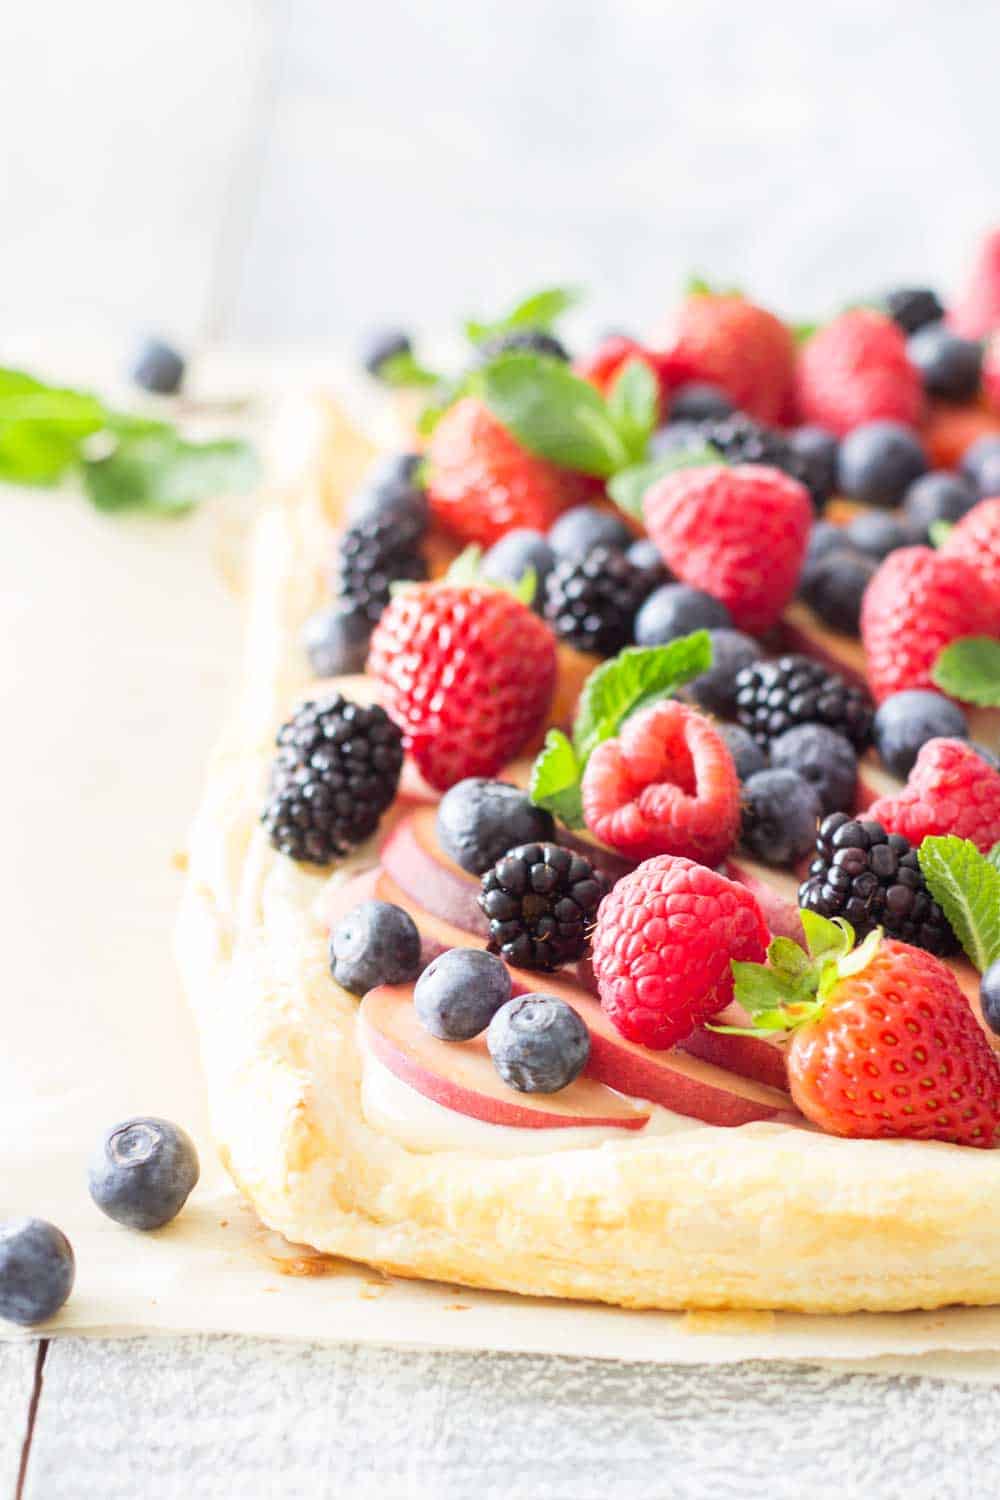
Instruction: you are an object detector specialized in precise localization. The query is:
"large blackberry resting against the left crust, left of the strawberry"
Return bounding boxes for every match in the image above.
[269,693,403,864]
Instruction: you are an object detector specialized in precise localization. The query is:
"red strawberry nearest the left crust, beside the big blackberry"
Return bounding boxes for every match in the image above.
[367,578,556,791]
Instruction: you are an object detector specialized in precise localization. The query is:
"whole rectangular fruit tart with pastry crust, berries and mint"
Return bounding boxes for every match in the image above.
[178,270,1000,1313]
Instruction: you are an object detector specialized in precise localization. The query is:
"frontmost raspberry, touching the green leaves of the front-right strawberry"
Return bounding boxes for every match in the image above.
[592,855,768,1050]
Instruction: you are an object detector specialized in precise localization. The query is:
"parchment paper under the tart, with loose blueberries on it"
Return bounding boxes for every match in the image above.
[0,369,1000,1379]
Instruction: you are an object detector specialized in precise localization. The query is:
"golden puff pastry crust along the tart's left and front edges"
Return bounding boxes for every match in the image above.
[178,396,1000,1313]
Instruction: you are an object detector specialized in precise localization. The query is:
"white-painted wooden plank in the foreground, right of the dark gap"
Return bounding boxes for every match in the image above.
[24,1337,1000,1500]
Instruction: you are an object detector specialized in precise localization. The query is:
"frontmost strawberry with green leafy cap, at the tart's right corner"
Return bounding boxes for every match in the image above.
[735,911,1000,1148]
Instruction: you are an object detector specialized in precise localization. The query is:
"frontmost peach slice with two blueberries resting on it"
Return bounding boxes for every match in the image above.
[360,984,649,1131]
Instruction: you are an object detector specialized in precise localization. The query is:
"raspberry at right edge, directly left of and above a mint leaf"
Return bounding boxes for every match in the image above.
[861,549,1000,704]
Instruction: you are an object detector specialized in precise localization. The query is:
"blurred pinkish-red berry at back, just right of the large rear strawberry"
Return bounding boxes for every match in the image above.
[796,308,924,437]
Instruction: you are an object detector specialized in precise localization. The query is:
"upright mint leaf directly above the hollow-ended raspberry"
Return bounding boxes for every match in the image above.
[573,630,712,764]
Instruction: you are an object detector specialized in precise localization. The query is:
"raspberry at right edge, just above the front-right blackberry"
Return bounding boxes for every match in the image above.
[868,740,1000,854]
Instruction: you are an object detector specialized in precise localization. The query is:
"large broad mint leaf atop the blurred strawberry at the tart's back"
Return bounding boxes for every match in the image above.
[471,353,628,477]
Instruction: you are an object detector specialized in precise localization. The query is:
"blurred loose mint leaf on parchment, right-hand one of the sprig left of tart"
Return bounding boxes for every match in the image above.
[82,429,258,515]
